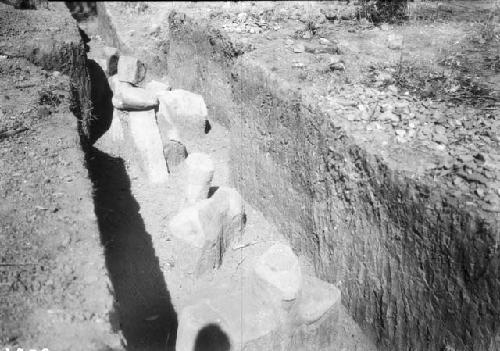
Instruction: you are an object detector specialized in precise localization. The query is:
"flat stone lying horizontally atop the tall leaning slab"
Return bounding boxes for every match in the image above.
[112,82,158,111]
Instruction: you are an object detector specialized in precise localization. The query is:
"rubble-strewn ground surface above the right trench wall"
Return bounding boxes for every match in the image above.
[98,1,500,223]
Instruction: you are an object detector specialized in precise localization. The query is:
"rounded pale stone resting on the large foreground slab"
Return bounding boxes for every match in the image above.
[253,243,302,311]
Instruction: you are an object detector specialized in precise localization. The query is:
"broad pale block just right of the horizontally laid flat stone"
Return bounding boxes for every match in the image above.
[158,89,208,139]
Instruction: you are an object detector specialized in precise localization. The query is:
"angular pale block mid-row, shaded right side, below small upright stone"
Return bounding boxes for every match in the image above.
[170,188,244,275]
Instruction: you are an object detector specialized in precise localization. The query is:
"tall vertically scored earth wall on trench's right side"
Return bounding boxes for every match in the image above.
[95,6,500,350]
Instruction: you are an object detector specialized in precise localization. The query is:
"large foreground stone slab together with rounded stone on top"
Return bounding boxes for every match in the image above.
[176,244,341,351]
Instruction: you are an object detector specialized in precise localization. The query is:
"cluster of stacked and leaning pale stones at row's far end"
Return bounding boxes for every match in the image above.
[98,48,208,183]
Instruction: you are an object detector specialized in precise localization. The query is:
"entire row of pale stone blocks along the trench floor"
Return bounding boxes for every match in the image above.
[95,49,341,351]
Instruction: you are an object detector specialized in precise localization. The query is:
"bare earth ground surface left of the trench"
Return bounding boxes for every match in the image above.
[0,3,123,351]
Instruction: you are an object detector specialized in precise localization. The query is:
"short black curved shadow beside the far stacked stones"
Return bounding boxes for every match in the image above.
[87,59,113,144]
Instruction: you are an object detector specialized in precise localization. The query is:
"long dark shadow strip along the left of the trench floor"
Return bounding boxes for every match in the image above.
[85,147,177,351]
